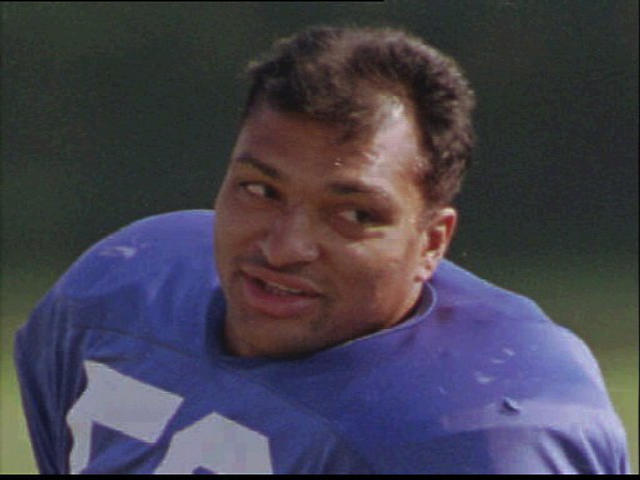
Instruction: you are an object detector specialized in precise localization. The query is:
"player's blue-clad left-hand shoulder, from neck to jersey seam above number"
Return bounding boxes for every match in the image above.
[19,210,218,350]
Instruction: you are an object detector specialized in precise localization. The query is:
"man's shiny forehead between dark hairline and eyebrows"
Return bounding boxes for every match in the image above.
[232,106,422,183]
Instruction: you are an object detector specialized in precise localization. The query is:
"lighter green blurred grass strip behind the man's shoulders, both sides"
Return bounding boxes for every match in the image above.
[0,258,638,474]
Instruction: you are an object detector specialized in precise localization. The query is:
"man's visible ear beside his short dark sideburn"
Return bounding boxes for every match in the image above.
[419,207,458,282]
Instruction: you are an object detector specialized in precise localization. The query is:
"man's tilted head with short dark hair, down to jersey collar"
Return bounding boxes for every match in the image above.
[215,28,473,356]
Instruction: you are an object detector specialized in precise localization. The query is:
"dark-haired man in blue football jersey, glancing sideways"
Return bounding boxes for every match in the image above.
[16,27,628,474]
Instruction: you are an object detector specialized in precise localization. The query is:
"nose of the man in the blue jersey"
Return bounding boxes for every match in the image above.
[260,208,319,267]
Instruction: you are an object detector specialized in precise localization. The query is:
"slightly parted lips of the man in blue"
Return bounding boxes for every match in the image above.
[240,265,321,318]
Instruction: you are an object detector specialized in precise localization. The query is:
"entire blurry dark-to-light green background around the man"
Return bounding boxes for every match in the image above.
[0,0,638,473]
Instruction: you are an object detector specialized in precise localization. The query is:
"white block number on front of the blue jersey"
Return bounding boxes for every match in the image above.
[67,360,272,473]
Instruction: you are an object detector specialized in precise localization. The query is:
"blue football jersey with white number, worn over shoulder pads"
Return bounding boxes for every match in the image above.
[15,211,629,474]
